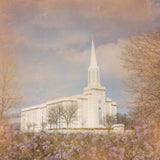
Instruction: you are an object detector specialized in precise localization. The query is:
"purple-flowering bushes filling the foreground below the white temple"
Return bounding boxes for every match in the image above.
[0,125,160,160]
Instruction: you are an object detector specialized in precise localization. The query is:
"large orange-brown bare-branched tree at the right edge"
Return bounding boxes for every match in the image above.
[122,33,160,125]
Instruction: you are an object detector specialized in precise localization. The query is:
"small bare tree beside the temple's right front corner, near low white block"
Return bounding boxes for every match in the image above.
[103,114,116,128]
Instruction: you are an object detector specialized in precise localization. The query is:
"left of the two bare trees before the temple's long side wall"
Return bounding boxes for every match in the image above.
[48,105,64,128]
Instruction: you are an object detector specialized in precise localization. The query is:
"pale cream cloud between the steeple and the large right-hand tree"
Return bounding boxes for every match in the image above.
[96,40,127,79]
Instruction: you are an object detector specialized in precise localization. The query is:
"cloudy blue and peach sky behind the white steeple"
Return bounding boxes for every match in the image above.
[0,0,160,113]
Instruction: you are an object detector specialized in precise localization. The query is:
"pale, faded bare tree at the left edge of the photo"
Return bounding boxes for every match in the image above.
[0,53,21,122]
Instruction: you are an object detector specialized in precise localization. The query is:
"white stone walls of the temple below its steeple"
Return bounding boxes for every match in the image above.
[21,95,117,131]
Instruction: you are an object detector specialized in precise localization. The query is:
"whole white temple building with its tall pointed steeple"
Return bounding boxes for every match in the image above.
[21,40,117,131]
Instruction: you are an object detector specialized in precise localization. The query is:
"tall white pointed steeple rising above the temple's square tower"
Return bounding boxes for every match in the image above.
[88,38,101,88]
